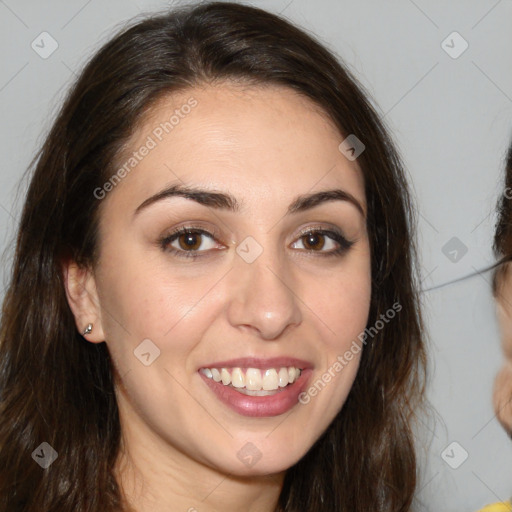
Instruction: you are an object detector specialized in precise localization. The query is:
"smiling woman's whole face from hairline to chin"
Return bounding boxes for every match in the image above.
[83,83,371,475]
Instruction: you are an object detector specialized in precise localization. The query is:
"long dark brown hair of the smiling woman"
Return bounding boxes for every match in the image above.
[0,2,426,512]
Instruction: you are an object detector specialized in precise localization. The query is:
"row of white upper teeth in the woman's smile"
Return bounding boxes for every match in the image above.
[200,366,302,396]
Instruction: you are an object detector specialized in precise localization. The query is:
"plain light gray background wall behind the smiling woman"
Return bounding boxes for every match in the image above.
[0,0,512,512]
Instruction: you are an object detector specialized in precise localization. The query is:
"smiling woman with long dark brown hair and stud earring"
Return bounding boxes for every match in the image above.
[0,2,425,512]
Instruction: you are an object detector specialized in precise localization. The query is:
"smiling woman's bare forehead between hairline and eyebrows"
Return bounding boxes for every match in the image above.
[106,79,365,214]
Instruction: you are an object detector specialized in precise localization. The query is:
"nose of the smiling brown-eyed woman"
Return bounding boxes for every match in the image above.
[227,241,302,340]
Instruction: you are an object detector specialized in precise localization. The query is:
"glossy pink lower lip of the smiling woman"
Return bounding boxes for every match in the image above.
[199,368,311,417]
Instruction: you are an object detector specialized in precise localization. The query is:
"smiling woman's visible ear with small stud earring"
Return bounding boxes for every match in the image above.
[62,260,105,343]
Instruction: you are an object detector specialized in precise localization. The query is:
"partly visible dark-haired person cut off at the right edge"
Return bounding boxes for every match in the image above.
[492,139,512,436]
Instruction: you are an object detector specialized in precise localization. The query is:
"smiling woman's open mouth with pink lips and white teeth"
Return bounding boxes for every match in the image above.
[198,358,312,417]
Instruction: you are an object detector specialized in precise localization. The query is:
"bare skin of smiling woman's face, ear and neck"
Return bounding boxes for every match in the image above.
[64,82,371,512]
